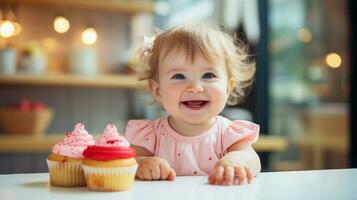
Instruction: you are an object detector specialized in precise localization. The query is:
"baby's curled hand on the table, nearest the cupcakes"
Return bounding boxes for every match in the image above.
[136,157,176,181]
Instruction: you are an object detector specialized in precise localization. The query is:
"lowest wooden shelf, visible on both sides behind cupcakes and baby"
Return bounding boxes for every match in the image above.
[0,134,287,153]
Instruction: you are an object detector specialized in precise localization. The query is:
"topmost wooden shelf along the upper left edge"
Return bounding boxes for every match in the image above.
[1,0,155,14]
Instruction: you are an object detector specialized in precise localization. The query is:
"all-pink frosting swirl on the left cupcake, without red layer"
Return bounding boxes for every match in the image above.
[52,123,94,158]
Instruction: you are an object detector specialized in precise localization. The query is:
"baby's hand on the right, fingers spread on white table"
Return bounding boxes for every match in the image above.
[208,160,253,185]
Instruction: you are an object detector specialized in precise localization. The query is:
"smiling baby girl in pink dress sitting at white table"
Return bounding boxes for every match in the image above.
[125,24,261,185]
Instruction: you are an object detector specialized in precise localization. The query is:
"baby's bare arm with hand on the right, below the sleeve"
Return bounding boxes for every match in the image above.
[208,140,261,185]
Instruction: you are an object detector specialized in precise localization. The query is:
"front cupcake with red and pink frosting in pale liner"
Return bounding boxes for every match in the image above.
[83,124,138,191]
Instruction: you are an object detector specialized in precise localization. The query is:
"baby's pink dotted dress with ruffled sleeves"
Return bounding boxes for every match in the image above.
[125,116,259,176]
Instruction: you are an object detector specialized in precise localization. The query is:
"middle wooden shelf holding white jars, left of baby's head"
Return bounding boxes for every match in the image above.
[0,74,145,89]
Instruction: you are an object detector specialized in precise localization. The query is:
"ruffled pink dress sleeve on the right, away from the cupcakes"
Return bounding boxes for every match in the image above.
[222,120,259,153]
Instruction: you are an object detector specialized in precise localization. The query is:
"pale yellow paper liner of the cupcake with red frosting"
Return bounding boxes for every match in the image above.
[83,164,138,191]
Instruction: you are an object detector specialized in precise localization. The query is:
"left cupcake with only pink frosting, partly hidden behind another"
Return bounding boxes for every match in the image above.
[47,123,94,187]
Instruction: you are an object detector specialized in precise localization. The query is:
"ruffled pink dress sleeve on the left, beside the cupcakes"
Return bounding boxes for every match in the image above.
[125,120,156,154]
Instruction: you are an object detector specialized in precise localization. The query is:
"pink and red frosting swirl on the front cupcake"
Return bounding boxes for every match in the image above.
[83,124,135,161]
